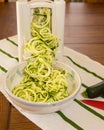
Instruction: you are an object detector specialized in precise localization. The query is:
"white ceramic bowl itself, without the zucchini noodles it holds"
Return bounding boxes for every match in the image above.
[4,62,81,114]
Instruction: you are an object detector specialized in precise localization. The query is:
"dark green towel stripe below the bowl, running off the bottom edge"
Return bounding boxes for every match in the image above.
[56,111,84,130]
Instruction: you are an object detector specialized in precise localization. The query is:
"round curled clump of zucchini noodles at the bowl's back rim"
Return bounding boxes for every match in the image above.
[25,57,52,81]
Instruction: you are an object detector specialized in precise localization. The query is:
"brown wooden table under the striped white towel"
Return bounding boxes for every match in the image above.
[0,3,104,130]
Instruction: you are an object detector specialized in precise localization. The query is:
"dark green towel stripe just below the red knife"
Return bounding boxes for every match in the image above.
[74,99,104,120]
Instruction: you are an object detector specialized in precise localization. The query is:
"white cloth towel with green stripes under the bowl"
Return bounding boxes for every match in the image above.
[0,36,104,130]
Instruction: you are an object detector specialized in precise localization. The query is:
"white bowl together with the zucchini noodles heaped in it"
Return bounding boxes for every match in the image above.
[5,58,81,114]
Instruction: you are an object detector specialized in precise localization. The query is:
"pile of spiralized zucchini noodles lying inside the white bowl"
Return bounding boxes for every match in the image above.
[12,62,69,102]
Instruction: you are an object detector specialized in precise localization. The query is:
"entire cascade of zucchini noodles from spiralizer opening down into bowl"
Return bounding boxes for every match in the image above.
[12,7,71,102]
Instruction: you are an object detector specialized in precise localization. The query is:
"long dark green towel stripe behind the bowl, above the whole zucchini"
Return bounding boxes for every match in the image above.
[66,56,104,80]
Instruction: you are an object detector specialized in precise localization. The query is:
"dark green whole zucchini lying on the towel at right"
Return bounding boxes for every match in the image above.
[86,81,104,98]
